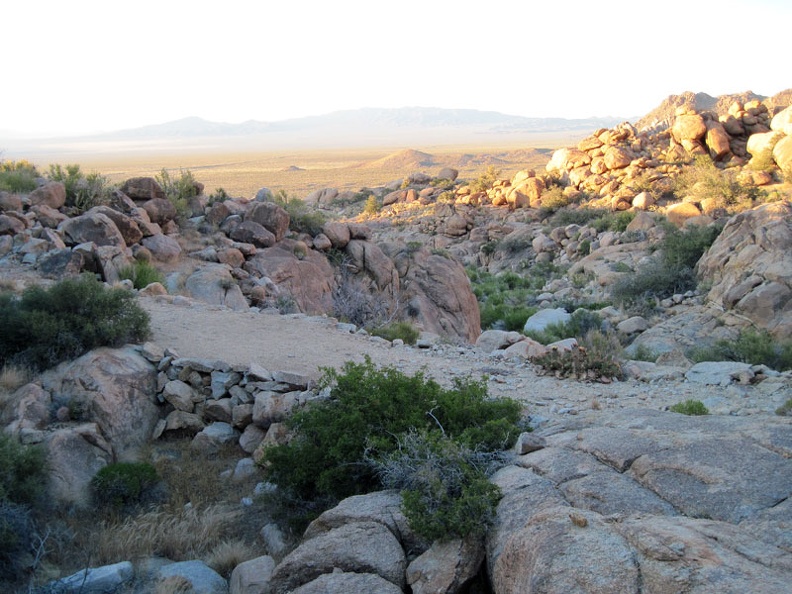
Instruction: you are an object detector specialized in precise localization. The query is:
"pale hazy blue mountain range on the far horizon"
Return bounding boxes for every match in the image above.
[3,107,624,158]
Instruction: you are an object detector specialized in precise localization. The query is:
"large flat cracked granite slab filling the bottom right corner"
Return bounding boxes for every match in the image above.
[487,410,792,594]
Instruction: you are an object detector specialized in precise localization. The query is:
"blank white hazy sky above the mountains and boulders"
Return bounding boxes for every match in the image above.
[0,0,792,139]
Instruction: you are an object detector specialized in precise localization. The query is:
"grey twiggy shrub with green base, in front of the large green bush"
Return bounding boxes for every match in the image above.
[374,432,505,542]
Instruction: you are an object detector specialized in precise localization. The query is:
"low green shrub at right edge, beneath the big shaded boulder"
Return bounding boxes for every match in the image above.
[690,329,792,371]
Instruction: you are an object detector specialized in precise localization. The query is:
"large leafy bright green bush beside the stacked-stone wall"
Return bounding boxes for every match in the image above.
[261,359,521,532]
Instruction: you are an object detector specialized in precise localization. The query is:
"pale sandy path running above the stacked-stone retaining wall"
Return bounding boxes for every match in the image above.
[140,296,783,420]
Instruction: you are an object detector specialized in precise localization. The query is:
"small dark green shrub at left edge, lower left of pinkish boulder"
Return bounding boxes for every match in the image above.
[0,432,47,505]
